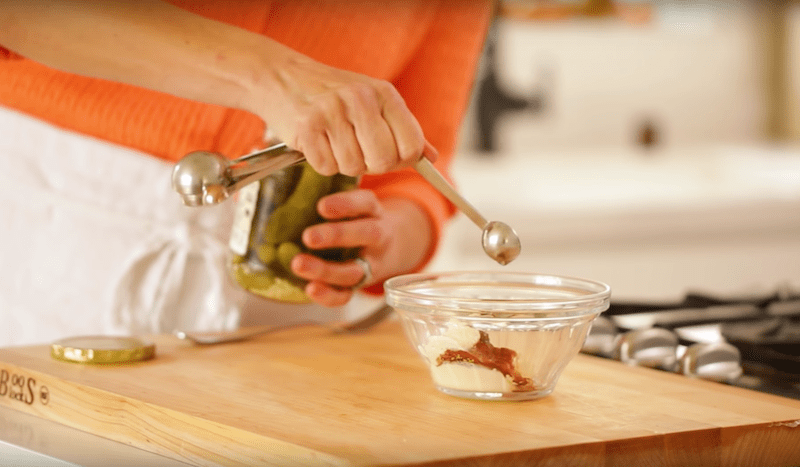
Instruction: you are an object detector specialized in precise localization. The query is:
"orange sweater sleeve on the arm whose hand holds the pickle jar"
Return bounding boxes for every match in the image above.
[362,0,492,293]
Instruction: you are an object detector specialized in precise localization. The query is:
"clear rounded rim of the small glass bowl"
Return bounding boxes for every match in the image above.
[384,271,611,319]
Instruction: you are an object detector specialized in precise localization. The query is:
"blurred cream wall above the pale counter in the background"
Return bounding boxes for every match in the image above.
[463,0,800,152]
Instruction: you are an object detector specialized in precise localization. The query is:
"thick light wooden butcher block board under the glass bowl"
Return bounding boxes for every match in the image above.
[0,321,800,467]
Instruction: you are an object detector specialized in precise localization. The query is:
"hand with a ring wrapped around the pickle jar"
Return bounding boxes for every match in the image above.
[291,189,433,307]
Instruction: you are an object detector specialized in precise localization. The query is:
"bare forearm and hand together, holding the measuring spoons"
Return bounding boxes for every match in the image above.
[0,0,432,176]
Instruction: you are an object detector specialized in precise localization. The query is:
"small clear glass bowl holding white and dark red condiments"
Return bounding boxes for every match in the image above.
[384,272,611,400]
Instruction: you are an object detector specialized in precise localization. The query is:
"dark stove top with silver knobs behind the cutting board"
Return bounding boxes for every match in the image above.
[583,290,800,400]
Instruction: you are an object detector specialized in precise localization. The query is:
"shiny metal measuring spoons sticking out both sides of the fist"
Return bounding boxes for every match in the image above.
[172,143,522,265]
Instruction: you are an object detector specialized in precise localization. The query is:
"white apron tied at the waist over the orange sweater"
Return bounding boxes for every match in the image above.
[0,108,371,347]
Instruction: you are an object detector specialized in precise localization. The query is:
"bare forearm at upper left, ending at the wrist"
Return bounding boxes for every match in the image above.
[0,0,288,116]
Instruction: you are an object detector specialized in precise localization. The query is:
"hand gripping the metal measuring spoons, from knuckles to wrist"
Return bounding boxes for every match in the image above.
[254,50,426,176]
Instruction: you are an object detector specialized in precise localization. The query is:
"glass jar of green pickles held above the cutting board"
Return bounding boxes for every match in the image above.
[229,162,359,303]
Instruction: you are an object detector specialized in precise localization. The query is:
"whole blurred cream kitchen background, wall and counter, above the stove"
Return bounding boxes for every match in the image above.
[432,0,800,300]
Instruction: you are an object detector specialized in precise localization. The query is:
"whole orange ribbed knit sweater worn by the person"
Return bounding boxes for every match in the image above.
[0,0,491,278]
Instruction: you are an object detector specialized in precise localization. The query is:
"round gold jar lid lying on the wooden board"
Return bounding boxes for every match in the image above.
[50,336,156,364]
